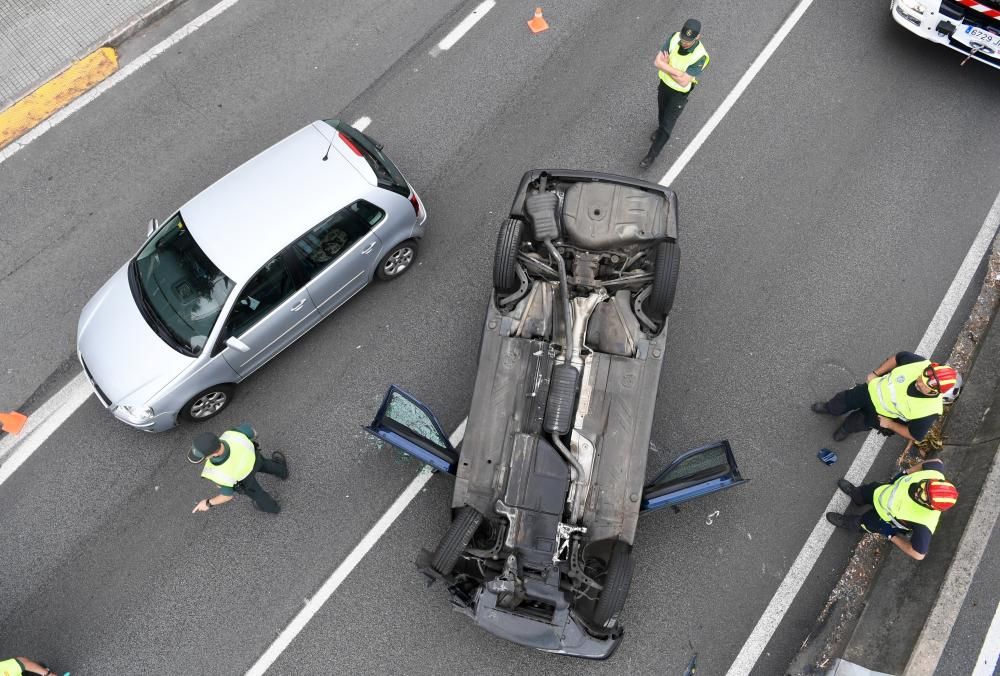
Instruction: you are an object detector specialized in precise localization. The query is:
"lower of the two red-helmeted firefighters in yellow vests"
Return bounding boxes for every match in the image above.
[826,459,958,561]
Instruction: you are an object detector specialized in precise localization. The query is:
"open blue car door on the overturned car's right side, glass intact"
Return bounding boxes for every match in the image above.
[639,440,745,513]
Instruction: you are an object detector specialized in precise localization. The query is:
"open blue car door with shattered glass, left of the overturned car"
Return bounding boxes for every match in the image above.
[364,385,458,474]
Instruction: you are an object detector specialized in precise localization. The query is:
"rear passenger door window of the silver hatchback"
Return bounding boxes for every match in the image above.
[292,200,385,279]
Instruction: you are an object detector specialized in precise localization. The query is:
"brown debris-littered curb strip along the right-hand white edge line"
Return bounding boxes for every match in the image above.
[786,234,1000,676]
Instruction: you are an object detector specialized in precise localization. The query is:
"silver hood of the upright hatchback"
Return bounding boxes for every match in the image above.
[76,264,194,405]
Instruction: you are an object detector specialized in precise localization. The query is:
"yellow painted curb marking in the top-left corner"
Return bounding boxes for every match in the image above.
[0,47,118,148]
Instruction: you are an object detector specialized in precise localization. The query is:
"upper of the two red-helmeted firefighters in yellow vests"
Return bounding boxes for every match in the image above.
[812,352,962,441]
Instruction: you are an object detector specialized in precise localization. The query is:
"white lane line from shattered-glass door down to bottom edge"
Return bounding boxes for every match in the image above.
[246,418,468,676]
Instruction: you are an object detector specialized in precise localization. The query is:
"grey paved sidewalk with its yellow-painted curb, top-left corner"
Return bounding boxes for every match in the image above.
[0,0,184,146]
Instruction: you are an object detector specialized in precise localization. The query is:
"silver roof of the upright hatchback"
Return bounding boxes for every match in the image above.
[180,121,375,284]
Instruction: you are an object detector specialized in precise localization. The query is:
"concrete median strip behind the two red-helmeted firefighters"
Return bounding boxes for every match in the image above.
[786,239,1000,676]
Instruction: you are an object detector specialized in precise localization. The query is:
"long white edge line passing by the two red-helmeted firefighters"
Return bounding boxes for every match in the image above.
[727,186,1000,676]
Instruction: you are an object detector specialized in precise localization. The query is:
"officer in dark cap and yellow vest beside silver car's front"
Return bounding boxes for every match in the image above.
[188,423,288,514]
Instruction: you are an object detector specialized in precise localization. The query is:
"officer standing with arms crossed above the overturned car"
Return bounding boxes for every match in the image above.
[639,19,709,169]
